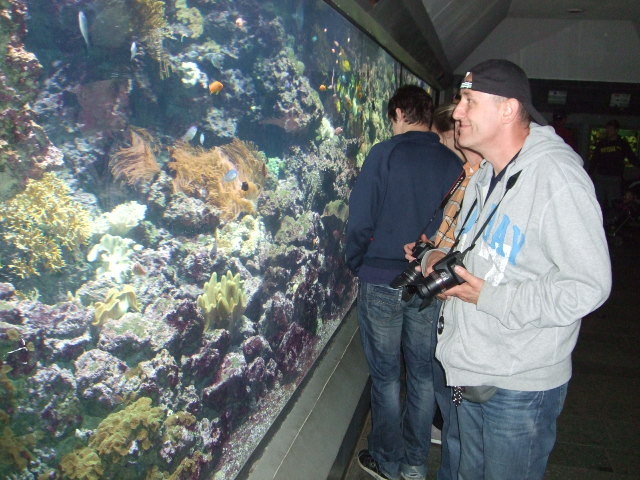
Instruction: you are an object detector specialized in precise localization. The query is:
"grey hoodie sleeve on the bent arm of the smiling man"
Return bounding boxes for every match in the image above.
[477,184,611,329]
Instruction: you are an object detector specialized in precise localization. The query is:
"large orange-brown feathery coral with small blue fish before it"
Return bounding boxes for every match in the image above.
[168,139,267,220]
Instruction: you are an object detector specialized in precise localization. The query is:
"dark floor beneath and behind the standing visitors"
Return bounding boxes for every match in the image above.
[345,232,640,480]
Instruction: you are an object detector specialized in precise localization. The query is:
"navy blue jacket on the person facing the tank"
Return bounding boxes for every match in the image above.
[346,131,462,283]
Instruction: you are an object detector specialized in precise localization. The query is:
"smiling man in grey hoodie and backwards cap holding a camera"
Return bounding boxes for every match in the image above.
[422,60,611,480]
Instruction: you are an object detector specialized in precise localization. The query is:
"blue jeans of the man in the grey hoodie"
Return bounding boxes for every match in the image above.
[458,384,567,480]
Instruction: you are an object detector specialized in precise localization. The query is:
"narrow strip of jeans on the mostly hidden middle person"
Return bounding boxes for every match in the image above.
[431,299,460,480]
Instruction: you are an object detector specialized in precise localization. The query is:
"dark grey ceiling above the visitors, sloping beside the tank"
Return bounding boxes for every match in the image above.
[327,0,640,88]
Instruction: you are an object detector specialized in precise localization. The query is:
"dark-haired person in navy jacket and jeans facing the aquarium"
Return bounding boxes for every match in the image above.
[346,85,462,480]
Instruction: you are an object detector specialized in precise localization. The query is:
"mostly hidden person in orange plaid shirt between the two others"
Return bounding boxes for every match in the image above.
[404,103,482,480]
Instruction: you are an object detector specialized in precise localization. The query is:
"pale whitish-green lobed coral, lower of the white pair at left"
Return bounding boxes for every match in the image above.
[87,233,142,283]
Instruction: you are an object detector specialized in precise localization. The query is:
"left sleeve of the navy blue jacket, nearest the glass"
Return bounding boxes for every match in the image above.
[345,144,388,273]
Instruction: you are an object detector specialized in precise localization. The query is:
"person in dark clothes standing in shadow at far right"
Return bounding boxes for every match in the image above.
[589,119,640,226]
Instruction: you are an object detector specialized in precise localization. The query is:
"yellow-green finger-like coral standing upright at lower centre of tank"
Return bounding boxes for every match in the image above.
[198,271,247,330]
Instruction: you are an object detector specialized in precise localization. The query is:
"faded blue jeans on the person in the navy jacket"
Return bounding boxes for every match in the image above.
[358,282,435,479]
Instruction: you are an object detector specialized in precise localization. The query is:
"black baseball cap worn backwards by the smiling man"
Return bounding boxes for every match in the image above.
[460,59,547,125]
